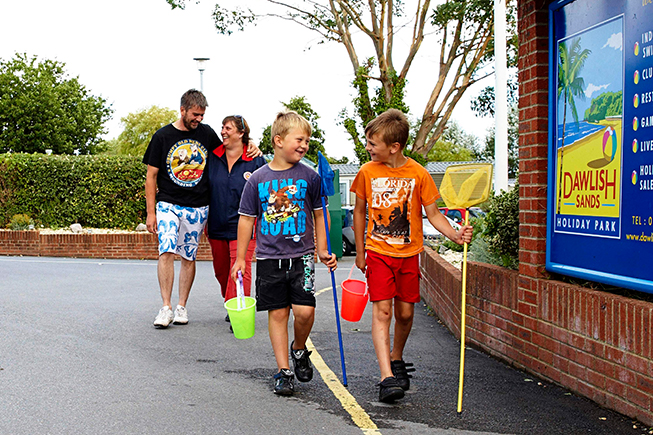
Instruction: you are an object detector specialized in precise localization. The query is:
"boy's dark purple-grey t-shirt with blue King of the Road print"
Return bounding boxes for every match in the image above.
[238,163,322,259]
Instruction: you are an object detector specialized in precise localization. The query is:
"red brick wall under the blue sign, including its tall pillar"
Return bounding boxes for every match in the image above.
[422,0,653,425]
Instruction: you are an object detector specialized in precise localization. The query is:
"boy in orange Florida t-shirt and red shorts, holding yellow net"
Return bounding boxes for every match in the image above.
[350,109,472,403]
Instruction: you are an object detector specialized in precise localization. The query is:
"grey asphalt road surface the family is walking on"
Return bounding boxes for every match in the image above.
[0,257,649,435]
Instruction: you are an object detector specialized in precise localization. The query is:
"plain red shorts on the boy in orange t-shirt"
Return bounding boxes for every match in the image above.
[365,250,421,303]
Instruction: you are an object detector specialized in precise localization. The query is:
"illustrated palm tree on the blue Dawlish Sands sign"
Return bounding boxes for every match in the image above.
[557,38,592,213]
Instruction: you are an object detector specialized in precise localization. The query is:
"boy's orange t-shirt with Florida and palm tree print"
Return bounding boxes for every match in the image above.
[349,158,440,257]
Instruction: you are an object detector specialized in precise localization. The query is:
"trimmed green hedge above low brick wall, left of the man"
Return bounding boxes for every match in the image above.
[0,154,147,229]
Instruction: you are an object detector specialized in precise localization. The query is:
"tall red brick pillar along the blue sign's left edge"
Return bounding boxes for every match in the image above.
[518,0,549,316]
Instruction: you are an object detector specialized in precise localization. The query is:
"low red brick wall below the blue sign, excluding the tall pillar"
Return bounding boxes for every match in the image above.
[422,250,653,425]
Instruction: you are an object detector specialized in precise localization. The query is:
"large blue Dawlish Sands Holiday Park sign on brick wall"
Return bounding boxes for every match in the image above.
[546,0,653,293]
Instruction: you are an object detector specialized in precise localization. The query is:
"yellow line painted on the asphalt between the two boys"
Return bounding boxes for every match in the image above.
[306,287,381,434]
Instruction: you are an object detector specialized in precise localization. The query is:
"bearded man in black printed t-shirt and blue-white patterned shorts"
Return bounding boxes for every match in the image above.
[143,89,222,328]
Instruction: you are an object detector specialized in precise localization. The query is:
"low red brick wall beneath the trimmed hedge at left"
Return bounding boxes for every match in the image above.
[0,231,211,260]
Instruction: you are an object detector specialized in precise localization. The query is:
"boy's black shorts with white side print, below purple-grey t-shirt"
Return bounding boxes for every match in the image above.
[256,254,315,311]
